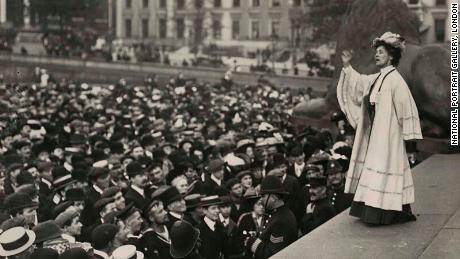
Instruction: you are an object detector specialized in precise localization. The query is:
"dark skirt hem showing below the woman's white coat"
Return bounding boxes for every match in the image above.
[350,201,417,225]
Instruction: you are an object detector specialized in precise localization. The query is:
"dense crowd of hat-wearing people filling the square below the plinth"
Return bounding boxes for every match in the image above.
[0,70,352,259]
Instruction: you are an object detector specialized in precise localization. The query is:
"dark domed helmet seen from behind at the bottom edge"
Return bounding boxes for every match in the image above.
[169,220,200,258]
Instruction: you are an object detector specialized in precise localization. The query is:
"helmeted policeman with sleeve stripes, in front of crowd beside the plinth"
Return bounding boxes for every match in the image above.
[246,175,298,258]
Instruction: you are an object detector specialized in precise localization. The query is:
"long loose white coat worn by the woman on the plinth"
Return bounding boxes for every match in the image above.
[337,66,423,211]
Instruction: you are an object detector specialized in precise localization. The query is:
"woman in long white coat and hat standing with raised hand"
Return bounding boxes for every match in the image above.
[337,32,423,224]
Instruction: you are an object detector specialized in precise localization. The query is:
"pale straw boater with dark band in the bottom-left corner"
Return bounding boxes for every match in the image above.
[0,227,35,256]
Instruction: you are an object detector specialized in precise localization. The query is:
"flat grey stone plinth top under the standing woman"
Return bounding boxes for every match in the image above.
[271,154,460,259]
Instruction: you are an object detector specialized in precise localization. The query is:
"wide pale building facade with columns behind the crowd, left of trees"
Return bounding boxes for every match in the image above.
[115,0,304,47]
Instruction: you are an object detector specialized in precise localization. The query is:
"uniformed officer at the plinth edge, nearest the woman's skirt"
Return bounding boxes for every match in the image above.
[326,160,353,214]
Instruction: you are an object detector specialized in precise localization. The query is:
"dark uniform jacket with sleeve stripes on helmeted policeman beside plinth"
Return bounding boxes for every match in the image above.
[248,205,298,258]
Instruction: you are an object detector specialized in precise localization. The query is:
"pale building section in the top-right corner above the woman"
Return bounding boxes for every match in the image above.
[404,0,452,44]
